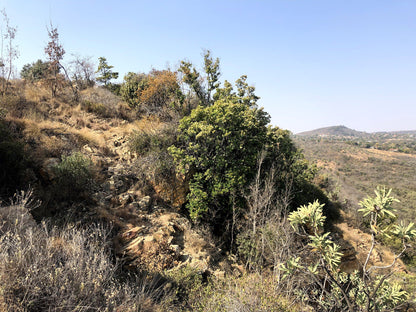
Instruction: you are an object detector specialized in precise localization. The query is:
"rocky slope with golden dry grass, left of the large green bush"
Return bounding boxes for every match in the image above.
[2,85,234,272]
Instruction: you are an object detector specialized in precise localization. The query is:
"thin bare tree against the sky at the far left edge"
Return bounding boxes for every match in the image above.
[0,9,19,96]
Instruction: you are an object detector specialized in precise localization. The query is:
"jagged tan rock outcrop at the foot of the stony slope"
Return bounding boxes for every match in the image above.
[119,210,219,271]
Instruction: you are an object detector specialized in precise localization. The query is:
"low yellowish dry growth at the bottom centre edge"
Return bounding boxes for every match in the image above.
[169,267,302,312]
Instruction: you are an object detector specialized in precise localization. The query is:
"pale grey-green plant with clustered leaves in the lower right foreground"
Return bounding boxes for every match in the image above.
[281,187,416,312]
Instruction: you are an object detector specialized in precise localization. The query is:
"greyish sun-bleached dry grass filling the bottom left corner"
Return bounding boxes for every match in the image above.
[0,191,172,311]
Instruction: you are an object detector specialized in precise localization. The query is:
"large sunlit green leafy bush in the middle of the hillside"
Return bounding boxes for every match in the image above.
[170,101,269,220]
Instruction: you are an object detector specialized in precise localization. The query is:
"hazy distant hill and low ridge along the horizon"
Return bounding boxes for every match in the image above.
[296,126,416,138]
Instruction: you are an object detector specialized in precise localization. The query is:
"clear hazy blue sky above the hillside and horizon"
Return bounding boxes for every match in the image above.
[0,0,416,133]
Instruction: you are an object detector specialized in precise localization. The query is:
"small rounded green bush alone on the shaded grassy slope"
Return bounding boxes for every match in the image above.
[53,152,94,199]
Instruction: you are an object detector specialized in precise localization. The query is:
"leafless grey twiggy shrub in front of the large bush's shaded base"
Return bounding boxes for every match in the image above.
[237,153,294,280]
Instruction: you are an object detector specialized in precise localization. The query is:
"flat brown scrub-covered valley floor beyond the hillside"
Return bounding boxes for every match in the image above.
[297,138,416,220]
